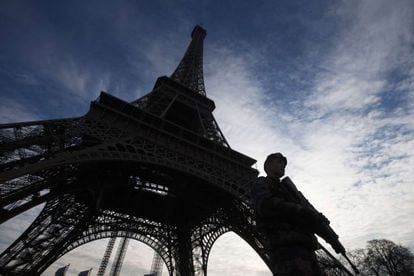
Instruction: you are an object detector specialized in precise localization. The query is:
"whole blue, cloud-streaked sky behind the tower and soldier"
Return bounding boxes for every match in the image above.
[0,0,414,275]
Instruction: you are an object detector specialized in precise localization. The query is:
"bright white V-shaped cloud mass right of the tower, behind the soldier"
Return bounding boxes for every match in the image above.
[207,1,414,256]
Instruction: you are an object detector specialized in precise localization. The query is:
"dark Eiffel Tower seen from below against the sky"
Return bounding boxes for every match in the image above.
[0,26,272,276]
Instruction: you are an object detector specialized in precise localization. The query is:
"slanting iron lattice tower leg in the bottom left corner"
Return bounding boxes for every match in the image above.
[0,195,91,275]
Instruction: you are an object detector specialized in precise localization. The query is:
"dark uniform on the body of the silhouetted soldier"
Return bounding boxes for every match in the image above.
[252,177,323,276]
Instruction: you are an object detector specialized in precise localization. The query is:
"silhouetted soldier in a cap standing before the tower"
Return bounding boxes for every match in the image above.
[252,153,329,276]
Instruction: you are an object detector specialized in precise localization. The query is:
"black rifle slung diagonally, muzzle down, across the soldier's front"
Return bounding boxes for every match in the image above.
[281,177,359,275]
